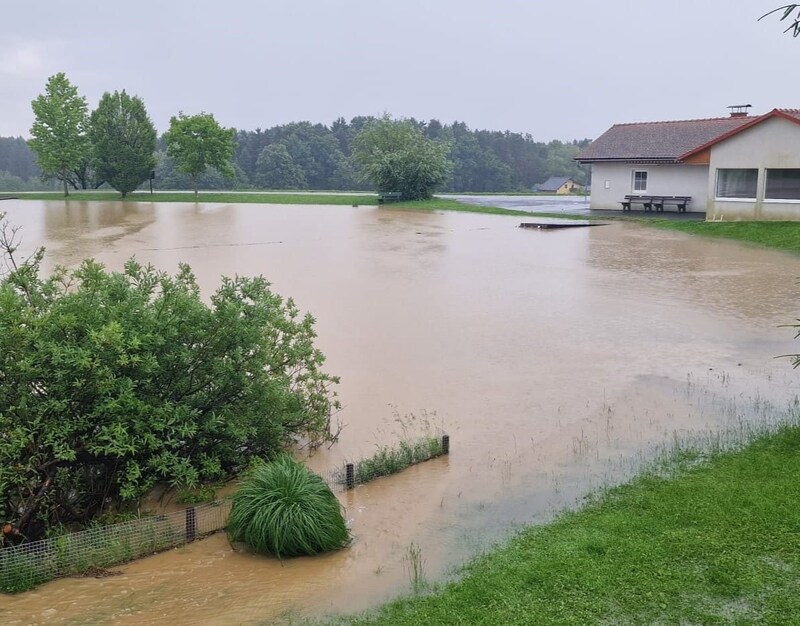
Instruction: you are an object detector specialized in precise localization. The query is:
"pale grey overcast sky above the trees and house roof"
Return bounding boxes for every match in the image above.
[0,0,800,141]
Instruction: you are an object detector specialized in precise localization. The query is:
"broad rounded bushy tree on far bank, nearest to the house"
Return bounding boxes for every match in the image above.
[352,114,452,200]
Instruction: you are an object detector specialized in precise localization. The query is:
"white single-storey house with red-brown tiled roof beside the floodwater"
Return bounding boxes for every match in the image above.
[576,109,800,220]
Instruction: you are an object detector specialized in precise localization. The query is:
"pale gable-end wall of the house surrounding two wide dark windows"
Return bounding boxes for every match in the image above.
[708,117,800,220]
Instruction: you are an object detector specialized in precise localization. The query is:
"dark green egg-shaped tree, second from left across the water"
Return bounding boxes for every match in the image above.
[89,90,156,198]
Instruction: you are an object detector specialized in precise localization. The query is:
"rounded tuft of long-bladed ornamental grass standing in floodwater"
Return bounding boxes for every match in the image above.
[228,455,350,558]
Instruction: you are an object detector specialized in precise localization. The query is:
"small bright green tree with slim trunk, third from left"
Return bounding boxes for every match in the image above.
[164,112,236,195]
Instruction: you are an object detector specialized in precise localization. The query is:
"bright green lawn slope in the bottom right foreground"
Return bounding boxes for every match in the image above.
[344,427,800,625]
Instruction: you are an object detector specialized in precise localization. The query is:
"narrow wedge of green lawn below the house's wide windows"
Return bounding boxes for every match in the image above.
[642,219,800,252]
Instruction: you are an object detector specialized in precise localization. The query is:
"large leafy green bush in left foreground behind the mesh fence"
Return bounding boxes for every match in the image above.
[0,238,338,545]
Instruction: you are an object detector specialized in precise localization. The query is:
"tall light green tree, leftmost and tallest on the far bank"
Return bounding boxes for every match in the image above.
[29,72,89,196]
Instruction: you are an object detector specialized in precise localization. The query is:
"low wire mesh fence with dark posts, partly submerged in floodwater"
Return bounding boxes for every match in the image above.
[0,435,450,593]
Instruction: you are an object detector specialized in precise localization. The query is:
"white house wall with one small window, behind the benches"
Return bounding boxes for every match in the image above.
[591,163,708,211]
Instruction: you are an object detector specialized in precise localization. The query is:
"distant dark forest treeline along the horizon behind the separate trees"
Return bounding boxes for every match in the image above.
[0,117,589,192]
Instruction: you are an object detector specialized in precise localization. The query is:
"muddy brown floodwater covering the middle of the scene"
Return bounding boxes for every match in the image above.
[0,201,800,624]
